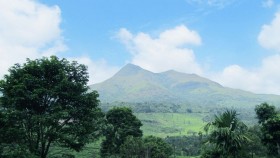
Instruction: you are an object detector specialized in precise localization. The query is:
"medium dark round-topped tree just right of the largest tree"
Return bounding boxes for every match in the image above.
[100,107,142,157]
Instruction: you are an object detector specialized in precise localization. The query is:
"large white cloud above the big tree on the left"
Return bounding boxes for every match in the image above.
[0,0,66,77]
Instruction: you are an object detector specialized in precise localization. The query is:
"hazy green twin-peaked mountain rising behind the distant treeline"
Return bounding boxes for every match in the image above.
[90,64,280,108]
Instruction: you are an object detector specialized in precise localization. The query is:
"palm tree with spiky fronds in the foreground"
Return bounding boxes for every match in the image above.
[205,110,249,157]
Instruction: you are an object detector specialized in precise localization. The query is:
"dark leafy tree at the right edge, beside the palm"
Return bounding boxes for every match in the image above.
[255,103,280,156]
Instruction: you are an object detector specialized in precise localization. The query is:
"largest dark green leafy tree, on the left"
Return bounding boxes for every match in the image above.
[0,56,103,158]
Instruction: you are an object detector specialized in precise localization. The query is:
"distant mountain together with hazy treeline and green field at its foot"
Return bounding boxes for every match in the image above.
[90,64,280,137]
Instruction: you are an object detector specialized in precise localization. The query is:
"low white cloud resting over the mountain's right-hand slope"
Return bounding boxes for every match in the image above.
[211,55,280,94]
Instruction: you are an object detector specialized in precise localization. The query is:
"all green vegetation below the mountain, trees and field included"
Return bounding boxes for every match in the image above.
[0,56,280,158]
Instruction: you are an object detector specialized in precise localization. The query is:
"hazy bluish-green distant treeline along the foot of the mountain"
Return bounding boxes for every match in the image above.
[100,101,257,125]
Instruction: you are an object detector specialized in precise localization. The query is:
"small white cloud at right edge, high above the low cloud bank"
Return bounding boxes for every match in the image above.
[258,12,280,52]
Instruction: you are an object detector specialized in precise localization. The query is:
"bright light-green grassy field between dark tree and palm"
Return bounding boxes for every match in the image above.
[134,113,205,138]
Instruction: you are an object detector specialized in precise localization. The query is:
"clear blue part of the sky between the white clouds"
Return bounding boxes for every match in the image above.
[42,0,277,67]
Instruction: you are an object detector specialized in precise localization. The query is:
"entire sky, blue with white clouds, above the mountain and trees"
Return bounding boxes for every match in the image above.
[0,0,280,95]
